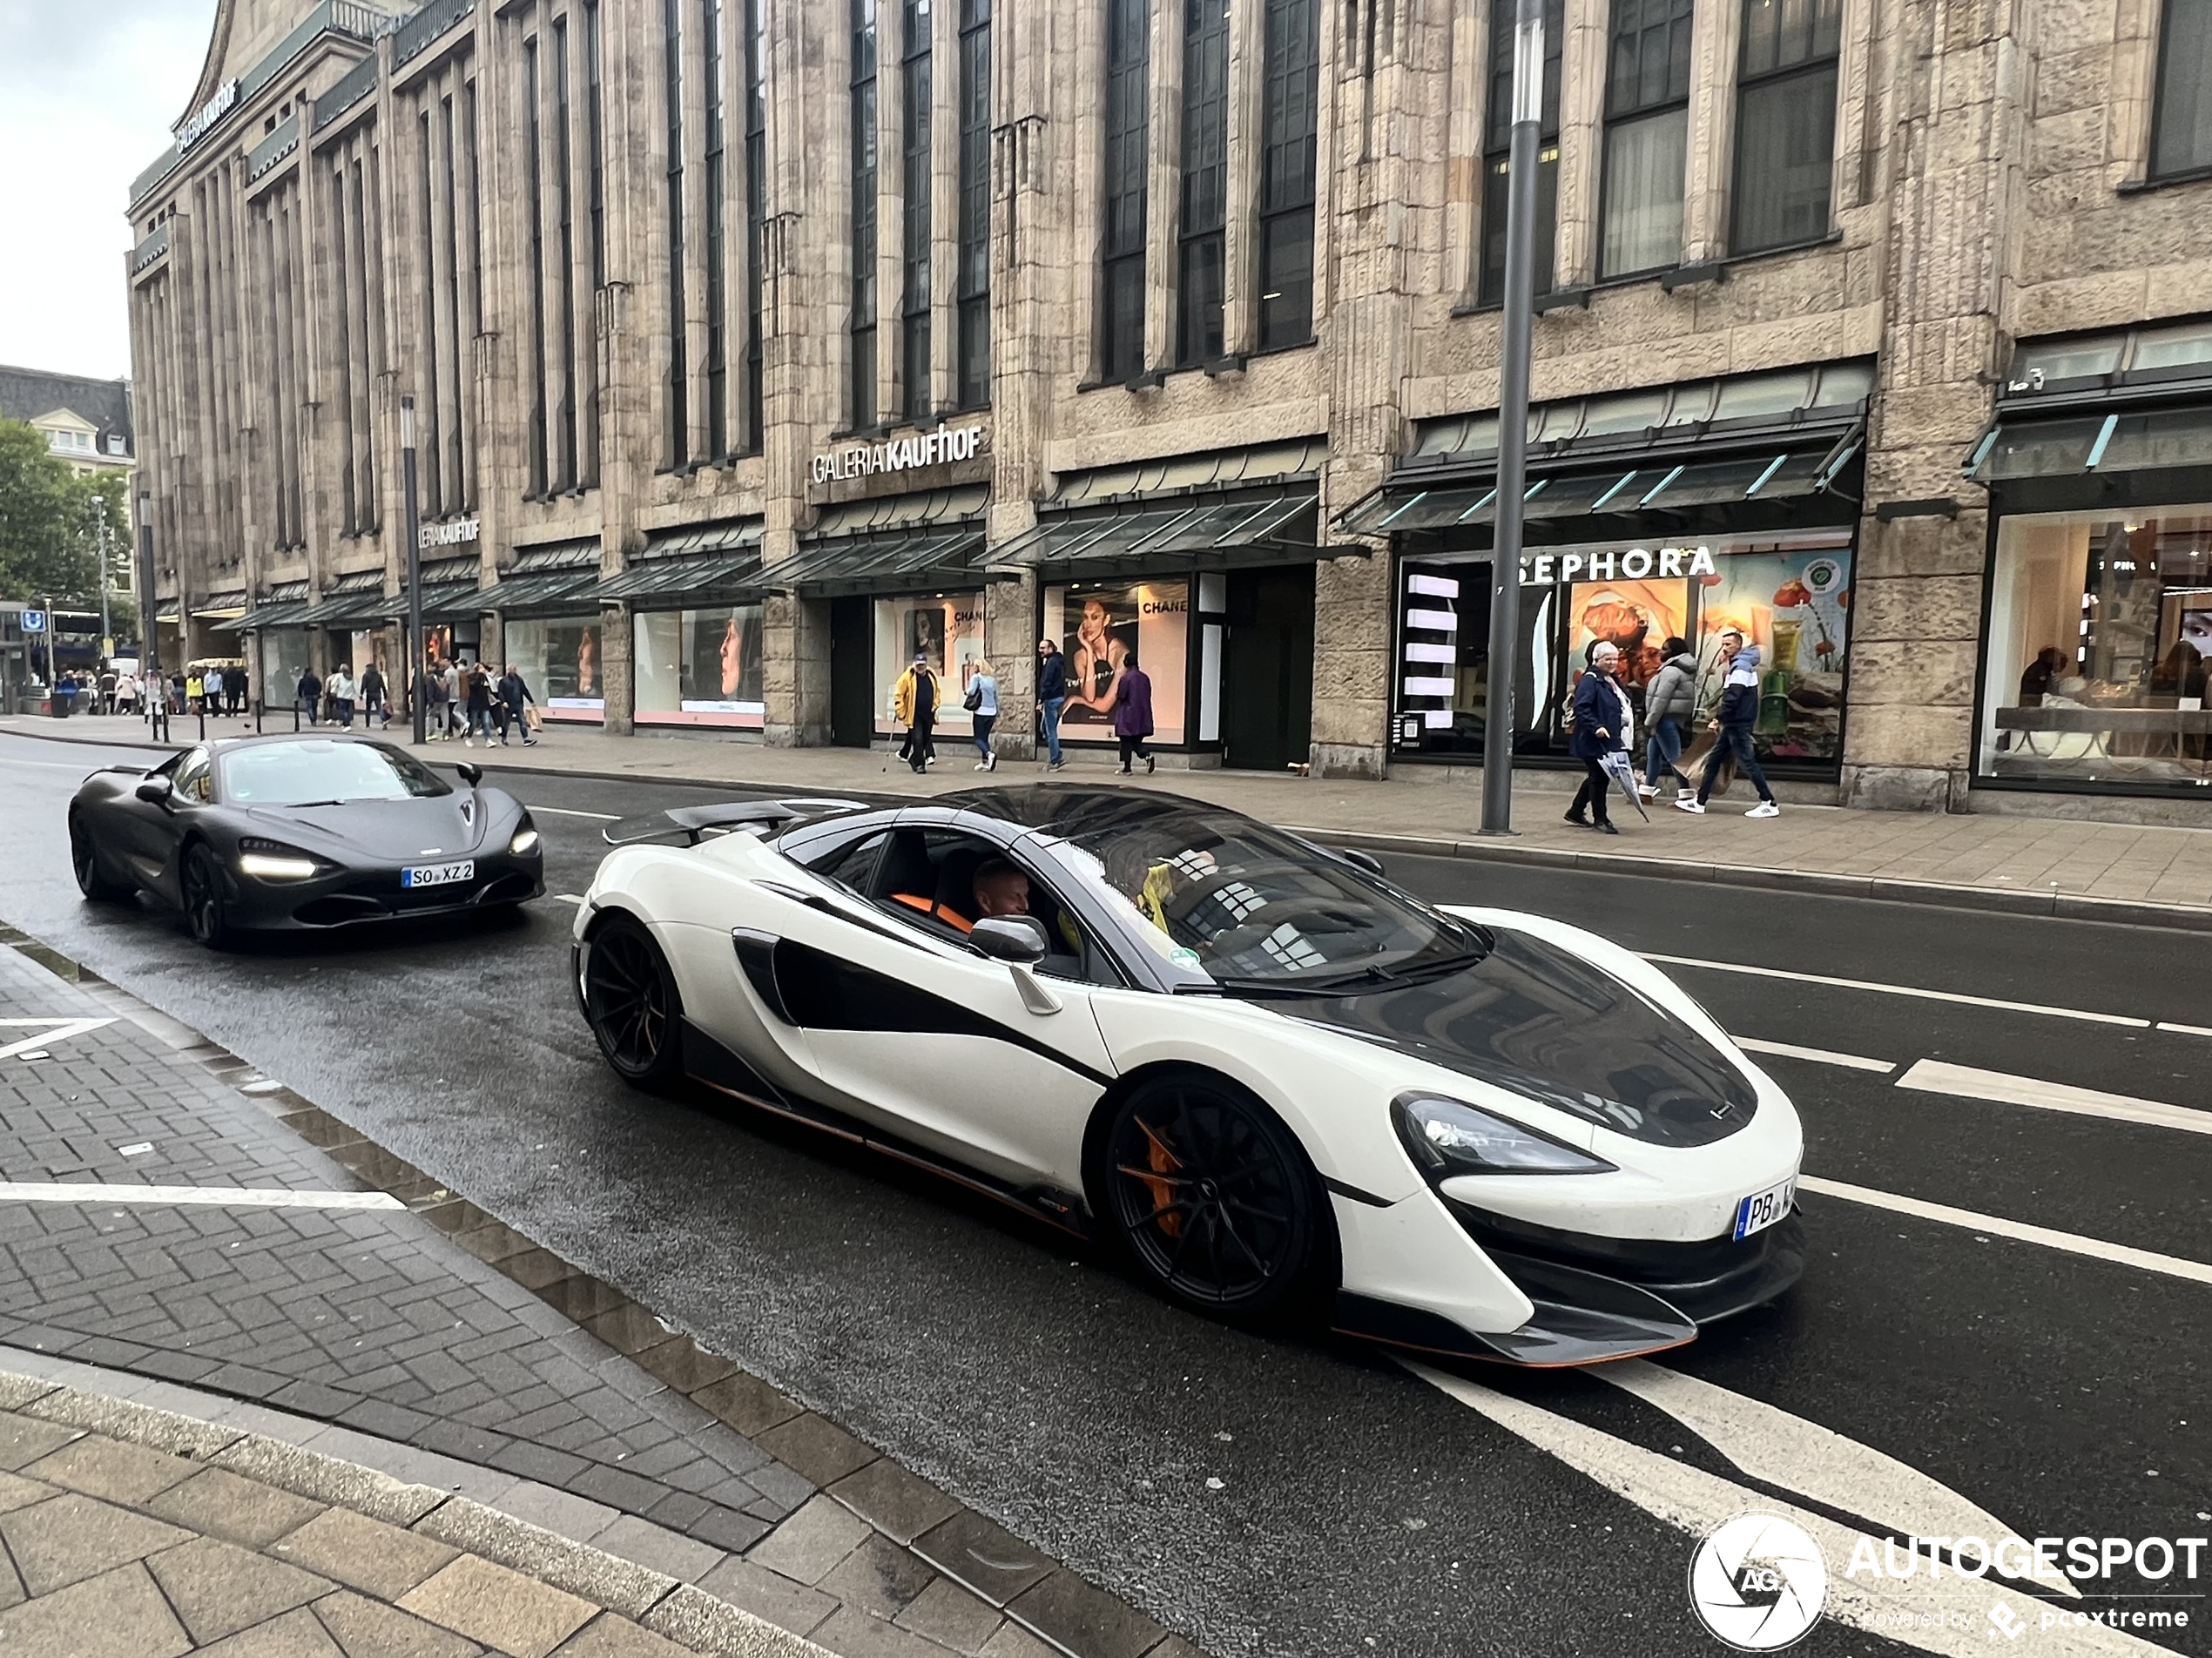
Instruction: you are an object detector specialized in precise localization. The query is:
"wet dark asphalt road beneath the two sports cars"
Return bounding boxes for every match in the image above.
[0,736,2212,1658]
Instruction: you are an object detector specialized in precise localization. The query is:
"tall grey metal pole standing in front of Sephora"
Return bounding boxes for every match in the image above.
[1482,0,1544,836]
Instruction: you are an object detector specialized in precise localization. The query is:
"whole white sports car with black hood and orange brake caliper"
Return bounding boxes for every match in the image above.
[575,785,1803,1364]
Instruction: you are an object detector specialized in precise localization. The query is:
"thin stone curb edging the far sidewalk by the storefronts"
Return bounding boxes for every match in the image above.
[4,727,2212,933]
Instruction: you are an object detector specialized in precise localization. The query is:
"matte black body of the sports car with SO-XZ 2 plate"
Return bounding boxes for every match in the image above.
[69,734,544,944]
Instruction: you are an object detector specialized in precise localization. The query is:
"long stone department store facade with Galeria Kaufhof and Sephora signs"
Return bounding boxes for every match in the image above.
[131,0,2212,822]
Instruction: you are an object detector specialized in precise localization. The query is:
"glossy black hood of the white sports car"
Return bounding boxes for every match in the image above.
[1283,927,1758,1148]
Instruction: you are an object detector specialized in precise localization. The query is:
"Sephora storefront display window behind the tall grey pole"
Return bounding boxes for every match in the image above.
[1392,530,1851,774]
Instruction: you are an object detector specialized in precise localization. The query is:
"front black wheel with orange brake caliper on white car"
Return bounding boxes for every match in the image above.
[1102,1076,1334,1318]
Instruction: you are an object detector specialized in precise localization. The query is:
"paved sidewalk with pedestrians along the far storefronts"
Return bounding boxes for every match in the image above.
[0,717,2212,931]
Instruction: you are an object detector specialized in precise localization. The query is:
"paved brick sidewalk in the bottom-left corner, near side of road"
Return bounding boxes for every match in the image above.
[0,928,1195,1658]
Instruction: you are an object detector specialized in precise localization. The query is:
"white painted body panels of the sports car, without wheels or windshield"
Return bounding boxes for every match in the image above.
[575,789,1803,1364]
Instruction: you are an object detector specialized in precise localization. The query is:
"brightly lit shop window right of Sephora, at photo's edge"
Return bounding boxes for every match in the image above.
[1978,506,2212,793]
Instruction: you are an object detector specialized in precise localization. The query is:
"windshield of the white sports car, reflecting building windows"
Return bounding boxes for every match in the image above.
[1043,807,1487,990]
